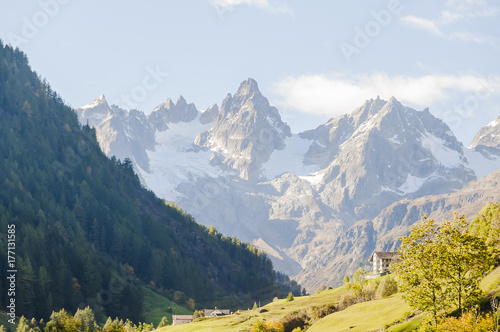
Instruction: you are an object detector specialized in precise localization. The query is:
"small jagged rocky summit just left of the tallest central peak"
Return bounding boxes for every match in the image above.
[148,96,199,131]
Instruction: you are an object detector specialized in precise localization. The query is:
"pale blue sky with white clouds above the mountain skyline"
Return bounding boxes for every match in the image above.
[0,0,500,146]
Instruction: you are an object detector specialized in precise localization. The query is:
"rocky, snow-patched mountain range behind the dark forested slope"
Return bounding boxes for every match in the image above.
[75,79,500,291]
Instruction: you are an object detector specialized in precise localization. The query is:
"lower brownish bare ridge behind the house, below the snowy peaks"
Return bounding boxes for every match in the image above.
[296,171,500,287]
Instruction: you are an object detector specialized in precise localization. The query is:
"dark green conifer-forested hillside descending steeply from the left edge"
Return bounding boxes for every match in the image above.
[0,42,286,321]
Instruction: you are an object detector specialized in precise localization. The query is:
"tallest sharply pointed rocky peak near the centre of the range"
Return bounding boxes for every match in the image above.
[195,78,291,180]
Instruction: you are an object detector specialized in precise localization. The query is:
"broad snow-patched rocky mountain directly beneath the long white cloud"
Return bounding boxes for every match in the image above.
[302,97,476,222]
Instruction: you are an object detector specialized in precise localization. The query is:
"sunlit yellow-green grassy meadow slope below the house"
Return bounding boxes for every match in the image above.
[153,267,500,332]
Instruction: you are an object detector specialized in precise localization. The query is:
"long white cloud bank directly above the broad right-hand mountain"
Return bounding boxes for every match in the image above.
[273,73,500,116]
